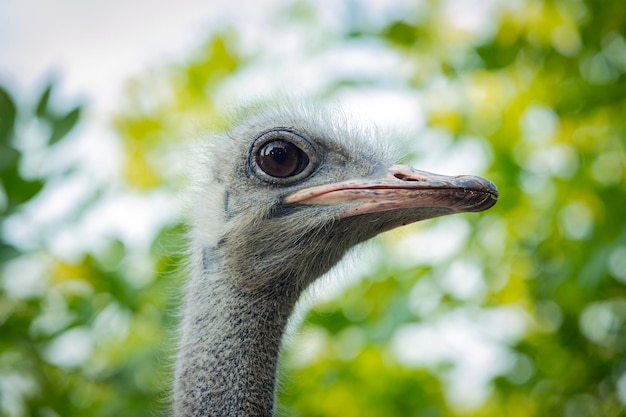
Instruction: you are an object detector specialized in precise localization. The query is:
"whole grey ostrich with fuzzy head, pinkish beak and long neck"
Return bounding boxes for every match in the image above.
[173,101,498,417]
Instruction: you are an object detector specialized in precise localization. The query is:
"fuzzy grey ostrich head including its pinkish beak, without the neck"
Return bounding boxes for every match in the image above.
[196,107,498,292]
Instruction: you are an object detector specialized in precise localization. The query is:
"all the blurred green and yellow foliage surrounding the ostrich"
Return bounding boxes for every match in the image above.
[0,0,626,417]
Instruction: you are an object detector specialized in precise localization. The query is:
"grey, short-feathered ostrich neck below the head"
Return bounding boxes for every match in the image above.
[169,245,297,417]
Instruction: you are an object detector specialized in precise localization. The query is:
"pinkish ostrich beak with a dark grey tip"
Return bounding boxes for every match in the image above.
[284,165,498,218]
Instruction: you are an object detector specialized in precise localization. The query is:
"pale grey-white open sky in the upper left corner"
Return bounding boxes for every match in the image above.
[0,0,272,109]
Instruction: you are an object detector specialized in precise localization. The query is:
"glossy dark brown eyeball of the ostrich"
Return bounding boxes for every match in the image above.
[258,140,309,178]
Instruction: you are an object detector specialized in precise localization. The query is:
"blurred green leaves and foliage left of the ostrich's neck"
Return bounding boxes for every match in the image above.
[0,84,182,416]
